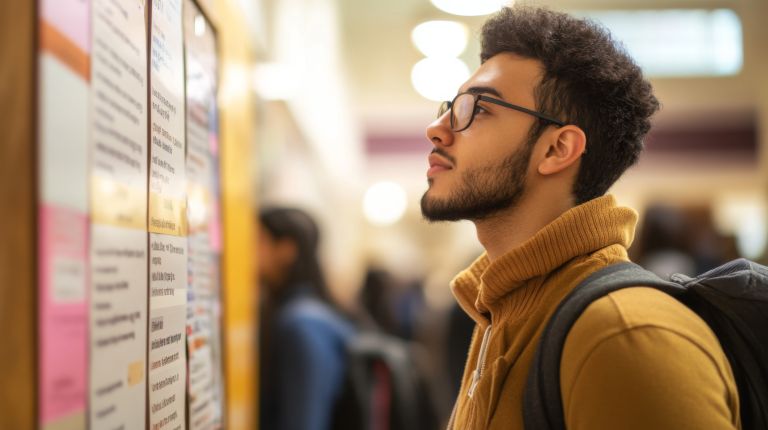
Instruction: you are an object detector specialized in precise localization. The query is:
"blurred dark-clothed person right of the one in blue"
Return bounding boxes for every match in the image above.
[352,266,438,430]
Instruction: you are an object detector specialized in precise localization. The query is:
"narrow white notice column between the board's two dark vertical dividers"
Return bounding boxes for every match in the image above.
[149,0,188,430]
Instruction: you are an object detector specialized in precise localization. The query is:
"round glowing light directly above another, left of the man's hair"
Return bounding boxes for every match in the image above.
[411,21,469,57]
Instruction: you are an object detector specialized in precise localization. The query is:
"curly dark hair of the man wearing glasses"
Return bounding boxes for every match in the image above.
[480,6,659,204]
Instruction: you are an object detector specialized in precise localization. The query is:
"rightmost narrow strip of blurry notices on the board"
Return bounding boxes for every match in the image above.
[184,0,223,430]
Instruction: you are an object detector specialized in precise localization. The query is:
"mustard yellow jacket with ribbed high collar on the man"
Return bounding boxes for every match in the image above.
[449,196,740,430]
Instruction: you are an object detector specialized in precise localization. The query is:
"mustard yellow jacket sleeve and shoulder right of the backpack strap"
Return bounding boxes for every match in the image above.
[560,289,740,430]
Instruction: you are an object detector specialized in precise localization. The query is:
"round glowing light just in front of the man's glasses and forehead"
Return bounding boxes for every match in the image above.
[411,57,469,101]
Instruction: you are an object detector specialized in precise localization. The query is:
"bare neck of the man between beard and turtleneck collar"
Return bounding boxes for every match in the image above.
[474,184,573,261]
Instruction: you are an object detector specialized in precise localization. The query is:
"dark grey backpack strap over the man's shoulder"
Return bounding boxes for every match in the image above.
[523,262,684,430]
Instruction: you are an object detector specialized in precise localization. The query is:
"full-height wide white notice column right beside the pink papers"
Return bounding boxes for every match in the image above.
[89,0,148,429]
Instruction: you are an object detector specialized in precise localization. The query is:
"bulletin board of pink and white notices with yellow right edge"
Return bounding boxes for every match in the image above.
[34,0,256,430]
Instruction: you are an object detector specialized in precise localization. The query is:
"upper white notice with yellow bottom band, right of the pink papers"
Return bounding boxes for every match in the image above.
[91,0,147,230]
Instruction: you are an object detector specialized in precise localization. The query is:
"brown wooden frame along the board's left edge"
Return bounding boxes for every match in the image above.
[0,1,38,429]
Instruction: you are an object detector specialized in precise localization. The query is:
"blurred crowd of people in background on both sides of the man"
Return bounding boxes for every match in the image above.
[257,204,756,430]
